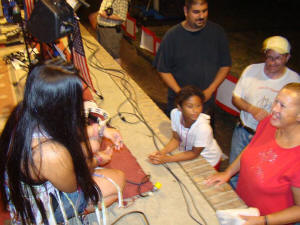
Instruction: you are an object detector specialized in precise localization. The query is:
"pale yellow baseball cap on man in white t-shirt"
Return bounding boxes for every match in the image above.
[263,36,291,54]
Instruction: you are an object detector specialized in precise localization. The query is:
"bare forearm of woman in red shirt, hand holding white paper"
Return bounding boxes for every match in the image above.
[241,187,300,225]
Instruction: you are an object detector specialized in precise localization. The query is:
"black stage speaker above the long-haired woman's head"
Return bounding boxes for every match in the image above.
[27,0,75,43]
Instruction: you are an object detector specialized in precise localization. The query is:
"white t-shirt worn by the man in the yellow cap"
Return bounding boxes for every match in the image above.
[233,63,300,130]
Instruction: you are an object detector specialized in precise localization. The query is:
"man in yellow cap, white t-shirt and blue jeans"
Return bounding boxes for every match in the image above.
[230,36,300,188]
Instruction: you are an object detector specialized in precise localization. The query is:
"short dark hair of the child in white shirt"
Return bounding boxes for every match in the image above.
[175,85,205,106]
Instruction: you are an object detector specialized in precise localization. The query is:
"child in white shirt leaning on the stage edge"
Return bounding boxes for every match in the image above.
[148,85,222,170]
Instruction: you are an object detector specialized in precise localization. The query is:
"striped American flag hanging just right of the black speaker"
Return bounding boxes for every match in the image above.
[72,20,94,89]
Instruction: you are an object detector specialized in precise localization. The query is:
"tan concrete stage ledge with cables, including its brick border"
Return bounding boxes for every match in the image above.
[76,26,245,225]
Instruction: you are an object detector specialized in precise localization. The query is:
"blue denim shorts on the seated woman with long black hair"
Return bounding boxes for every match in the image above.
[52,190,87,223]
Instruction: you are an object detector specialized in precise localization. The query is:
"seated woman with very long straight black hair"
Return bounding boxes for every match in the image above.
[0,60,125,224]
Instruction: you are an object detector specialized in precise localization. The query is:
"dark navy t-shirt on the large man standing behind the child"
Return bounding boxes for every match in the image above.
[153,21,231,105]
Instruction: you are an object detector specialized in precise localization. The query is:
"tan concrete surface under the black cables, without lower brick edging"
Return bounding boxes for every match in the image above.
[78,25,226,225]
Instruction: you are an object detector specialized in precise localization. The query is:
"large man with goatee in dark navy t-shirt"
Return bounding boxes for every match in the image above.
[154,0,231,118]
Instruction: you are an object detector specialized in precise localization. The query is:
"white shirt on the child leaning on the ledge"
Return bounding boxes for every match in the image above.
[171,108,222,166]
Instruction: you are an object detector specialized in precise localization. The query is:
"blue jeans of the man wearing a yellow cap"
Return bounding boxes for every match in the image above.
[229,125,253,189]
